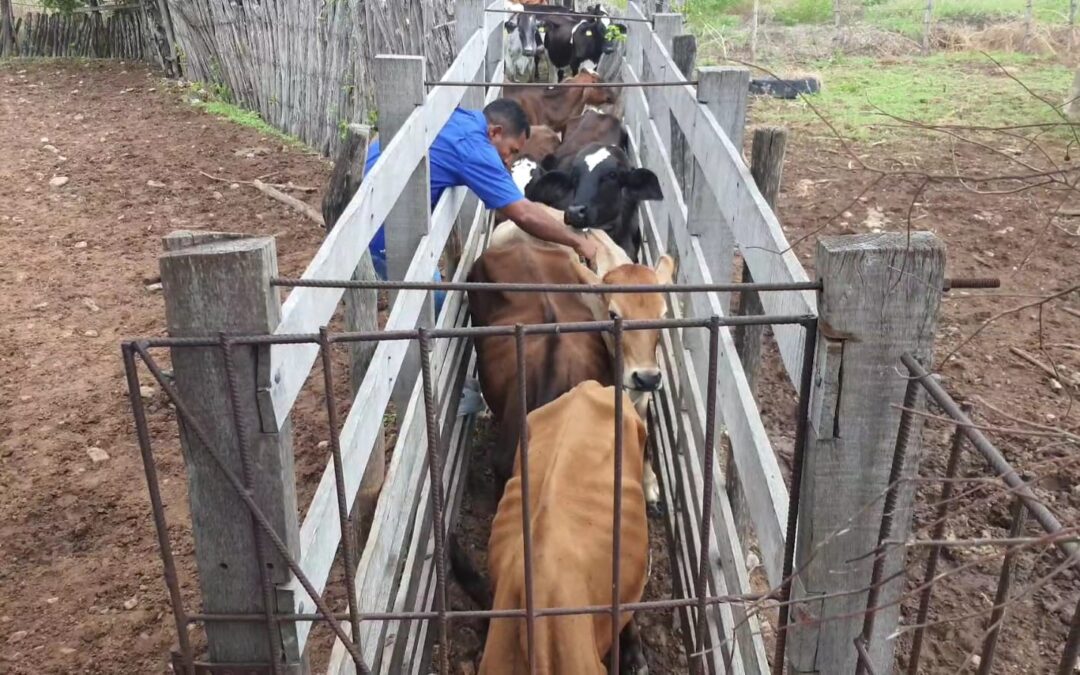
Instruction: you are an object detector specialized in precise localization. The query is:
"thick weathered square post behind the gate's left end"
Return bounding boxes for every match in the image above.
[159,232,307,672]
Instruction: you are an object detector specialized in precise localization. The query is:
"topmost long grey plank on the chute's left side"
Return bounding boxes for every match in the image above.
[268,27,487,423]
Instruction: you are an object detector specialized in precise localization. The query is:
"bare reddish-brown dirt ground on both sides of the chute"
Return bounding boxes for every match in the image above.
[0,63,1080,674]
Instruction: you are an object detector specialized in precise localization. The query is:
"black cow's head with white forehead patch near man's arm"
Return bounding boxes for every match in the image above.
[521,143,663,260]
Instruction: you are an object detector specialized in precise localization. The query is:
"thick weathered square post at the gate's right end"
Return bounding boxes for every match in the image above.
[787,232,945,673]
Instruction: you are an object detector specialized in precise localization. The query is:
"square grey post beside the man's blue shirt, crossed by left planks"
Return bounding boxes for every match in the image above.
[375,54,435,414]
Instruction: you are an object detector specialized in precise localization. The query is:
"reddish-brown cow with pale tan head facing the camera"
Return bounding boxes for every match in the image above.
[469,222,675,508]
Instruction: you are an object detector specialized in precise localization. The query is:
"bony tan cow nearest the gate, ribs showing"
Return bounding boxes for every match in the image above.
[480,381,649,675]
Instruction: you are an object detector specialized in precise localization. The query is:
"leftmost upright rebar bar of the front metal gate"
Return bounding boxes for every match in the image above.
[121,345,195,675]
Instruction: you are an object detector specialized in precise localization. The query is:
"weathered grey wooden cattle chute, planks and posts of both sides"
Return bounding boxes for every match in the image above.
[125,0,1071,674]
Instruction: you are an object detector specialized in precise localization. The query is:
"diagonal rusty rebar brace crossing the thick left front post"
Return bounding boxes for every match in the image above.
[132,342,369,675]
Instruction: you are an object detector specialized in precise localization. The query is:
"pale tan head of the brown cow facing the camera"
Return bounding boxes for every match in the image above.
[575,230,675,416]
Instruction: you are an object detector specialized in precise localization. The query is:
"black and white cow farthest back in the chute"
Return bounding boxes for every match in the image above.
[525,4,626,81]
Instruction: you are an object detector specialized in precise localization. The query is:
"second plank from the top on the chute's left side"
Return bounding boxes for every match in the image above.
[287,188,465,647]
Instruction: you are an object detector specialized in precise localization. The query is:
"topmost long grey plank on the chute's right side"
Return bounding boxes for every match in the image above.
[630,30,816,389]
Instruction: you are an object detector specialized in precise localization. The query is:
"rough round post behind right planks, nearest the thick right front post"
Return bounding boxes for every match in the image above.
[724,126,787,552]
